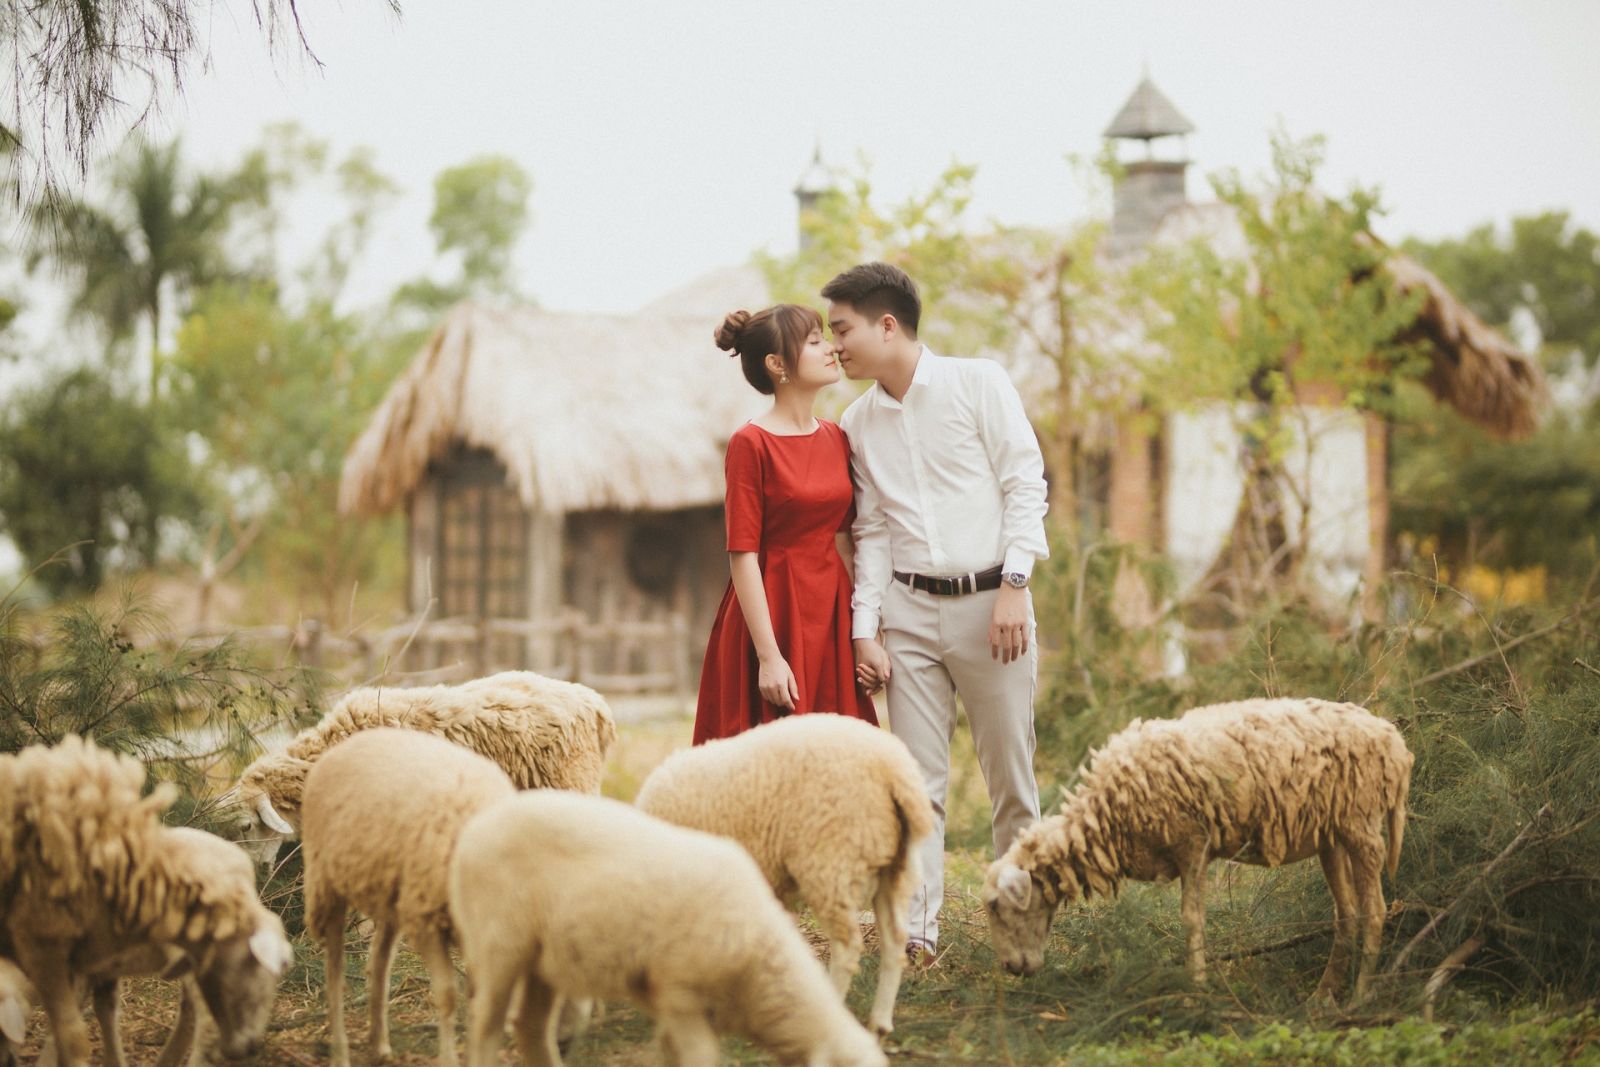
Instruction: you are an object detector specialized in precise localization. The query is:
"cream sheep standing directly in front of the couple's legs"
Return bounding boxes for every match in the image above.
[635,715,933,1035]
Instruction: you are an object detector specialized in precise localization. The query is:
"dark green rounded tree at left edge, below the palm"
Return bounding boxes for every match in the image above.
[0,368,197,593]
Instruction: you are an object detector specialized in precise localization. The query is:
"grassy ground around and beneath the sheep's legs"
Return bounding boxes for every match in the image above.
[3,718,1600,1067]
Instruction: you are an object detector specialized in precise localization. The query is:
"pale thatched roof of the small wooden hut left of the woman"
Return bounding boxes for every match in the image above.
[339,302,763,514]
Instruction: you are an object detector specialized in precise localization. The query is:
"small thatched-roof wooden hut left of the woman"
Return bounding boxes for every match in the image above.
[339,302,762,693]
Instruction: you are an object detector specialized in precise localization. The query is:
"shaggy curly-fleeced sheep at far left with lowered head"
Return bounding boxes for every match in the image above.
[0,737,293,1067]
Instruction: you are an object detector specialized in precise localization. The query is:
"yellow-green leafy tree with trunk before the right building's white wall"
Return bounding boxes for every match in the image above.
[1133,134,1426,603]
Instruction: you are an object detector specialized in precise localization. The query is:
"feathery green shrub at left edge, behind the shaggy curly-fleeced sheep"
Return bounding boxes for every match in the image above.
[0,597,307,796]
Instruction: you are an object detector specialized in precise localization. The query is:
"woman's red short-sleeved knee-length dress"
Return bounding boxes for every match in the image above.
[694,419,878,744]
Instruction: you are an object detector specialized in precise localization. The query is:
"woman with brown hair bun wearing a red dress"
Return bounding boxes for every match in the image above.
[694,304,878,744]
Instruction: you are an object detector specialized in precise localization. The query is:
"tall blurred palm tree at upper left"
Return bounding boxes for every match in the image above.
[29,141,238,397]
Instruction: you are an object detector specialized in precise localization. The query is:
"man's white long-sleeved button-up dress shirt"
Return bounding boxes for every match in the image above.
[838,346,1050,638]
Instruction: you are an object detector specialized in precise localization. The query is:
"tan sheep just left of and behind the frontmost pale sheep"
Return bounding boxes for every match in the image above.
[302,728,515,1067]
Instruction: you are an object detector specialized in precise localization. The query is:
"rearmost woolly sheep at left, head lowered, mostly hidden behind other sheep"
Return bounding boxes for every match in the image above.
[232,670,616,864]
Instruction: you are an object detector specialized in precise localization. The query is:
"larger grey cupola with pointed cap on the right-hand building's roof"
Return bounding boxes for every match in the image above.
[1104,74,1195,256]
